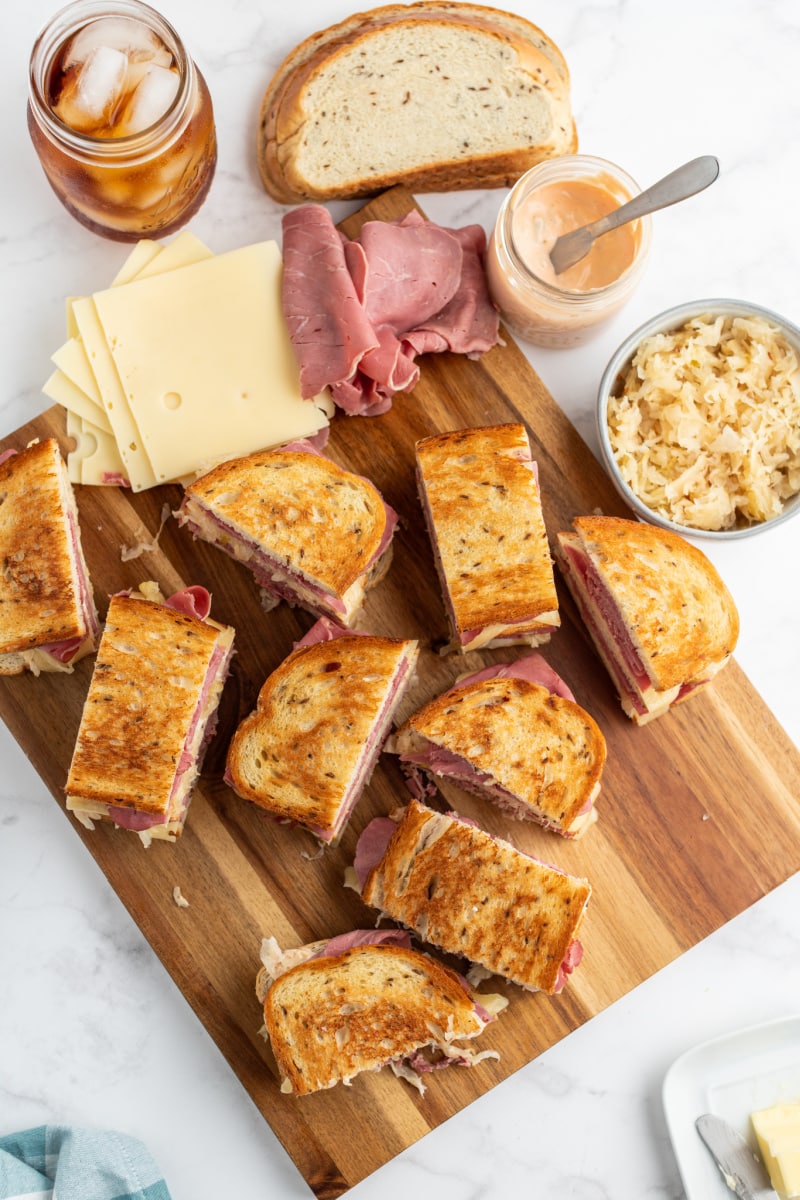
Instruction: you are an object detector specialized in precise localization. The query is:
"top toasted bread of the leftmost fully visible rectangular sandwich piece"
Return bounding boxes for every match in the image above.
[66,595,233,814]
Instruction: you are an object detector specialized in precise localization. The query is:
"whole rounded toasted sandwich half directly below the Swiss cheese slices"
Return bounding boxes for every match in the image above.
[176,442,397,626]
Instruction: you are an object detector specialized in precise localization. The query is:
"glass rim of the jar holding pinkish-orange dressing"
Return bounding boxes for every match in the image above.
[498,155,651,307]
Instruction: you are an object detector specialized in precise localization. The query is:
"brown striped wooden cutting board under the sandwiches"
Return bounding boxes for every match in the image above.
[0,191,800,1198]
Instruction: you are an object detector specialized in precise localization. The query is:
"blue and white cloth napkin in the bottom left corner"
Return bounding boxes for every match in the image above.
[0,1126,169,1200]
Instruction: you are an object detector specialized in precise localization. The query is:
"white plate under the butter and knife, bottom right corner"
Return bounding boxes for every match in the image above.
[662,1016,800,1200]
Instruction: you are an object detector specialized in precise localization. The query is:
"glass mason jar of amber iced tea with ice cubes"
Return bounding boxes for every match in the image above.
[28,0,217,241]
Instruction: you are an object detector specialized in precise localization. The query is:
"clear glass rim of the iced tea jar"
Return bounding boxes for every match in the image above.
[28,0,194,158]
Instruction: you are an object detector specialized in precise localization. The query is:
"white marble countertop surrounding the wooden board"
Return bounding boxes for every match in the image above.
[0,0,800,1200]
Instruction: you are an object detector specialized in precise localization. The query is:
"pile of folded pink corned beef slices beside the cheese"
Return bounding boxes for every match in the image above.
[283,204,499,415]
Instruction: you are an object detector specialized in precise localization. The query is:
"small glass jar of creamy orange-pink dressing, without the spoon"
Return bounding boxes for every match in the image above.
[486,155,651,347]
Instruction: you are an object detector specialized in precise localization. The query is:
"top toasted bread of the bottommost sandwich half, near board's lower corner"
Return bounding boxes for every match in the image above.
[264,946,483,1096]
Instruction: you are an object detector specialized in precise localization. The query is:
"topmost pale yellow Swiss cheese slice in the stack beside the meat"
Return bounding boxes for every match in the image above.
[89,241,331,491]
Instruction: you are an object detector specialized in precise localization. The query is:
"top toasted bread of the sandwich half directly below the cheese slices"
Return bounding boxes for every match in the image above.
[186,450,386,596]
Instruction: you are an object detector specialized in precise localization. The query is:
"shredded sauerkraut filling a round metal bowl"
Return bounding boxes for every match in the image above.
[597,300,800,538]
